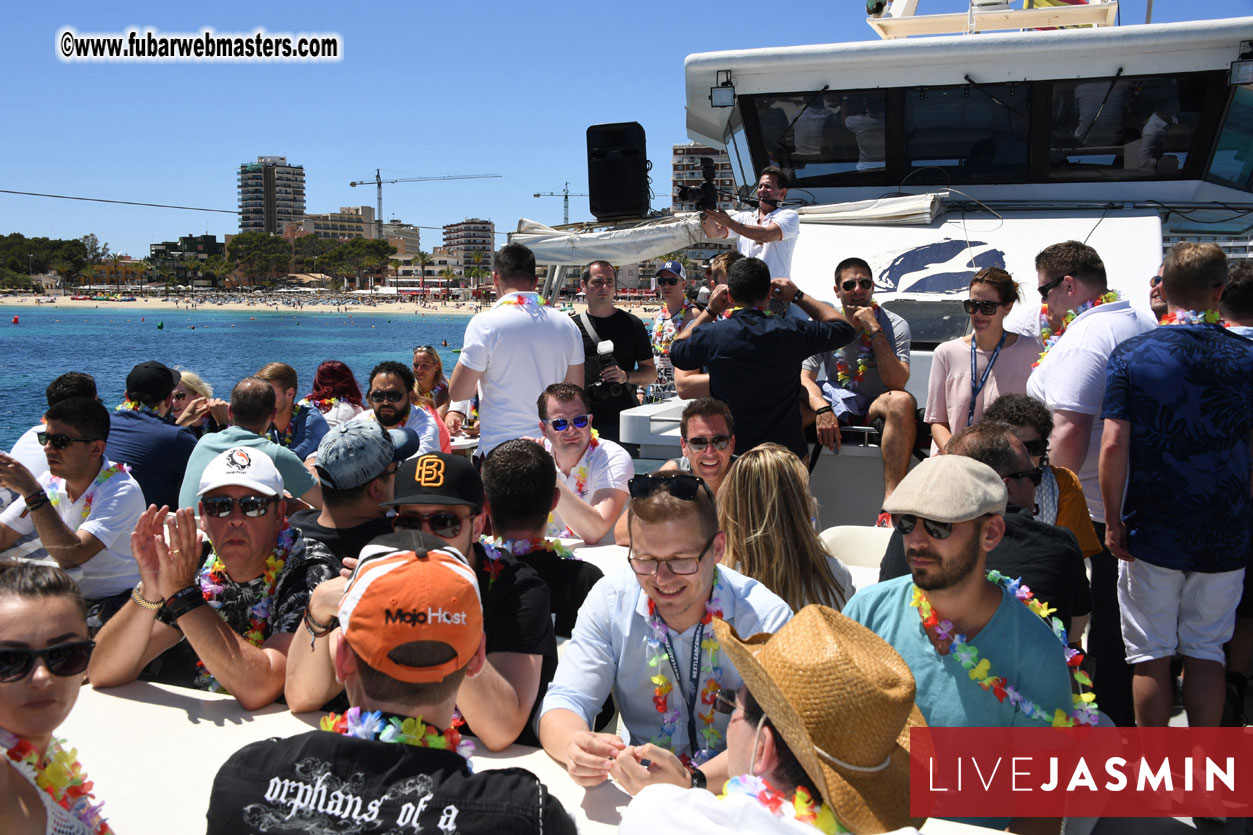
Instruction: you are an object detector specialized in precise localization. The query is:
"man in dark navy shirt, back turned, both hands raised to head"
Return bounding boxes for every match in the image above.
[670,258,856,459]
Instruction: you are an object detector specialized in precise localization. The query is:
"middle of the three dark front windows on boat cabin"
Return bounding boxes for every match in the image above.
[905,84,1030,183]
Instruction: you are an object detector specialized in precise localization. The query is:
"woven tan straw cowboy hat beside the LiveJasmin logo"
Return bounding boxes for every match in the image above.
[713,606,926,834]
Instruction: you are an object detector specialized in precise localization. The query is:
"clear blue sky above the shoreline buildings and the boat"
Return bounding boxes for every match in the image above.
[0,0,1253,258]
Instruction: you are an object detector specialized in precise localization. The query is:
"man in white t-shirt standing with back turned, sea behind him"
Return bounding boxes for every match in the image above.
[445,243,583,456]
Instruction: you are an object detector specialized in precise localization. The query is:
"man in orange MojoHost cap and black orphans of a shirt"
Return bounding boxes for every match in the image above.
[207,532,575,835]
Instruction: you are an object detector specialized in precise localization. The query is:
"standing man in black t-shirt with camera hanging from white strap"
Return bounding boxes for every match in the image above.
[574,261,657,441]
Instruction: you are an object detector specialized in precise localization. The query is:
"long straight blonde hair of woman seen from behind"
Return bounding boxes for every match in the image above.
[718,444,855,612]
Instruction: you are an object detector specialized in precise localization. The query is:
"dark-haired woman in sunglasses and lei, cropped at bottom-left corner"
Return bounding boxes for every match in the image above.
[0,563,112,835]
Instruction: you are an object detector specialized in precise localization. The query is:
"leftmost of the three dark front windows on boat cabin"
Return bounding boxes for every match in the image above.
[753,90,886,187]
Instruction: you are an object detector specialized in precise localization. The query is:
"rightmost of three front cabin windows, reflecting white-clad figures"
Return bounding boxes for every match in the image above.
[1049,76,1205,181]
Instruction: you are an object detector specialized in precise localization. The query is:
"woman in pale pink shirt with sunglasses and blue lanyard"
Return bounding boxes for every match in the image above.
[925,267,1044,455]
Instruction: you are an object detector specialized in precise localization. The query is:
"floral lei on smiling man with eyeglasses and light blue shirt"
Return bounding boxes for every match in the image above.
[648,569,723,765]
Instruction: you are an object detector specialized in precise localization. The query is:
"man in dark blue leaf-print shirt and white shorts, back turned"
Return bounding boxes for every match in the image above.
[1100,243,1253,727]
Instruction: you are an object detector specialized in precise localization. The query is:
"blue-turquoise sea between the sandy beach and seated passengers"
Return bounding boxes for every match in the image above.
[0,305,470,450]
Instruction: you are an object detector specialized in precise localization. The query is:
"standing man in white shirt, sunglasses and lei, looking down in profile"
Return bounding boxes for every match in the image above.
[1026,241,1157,726]
